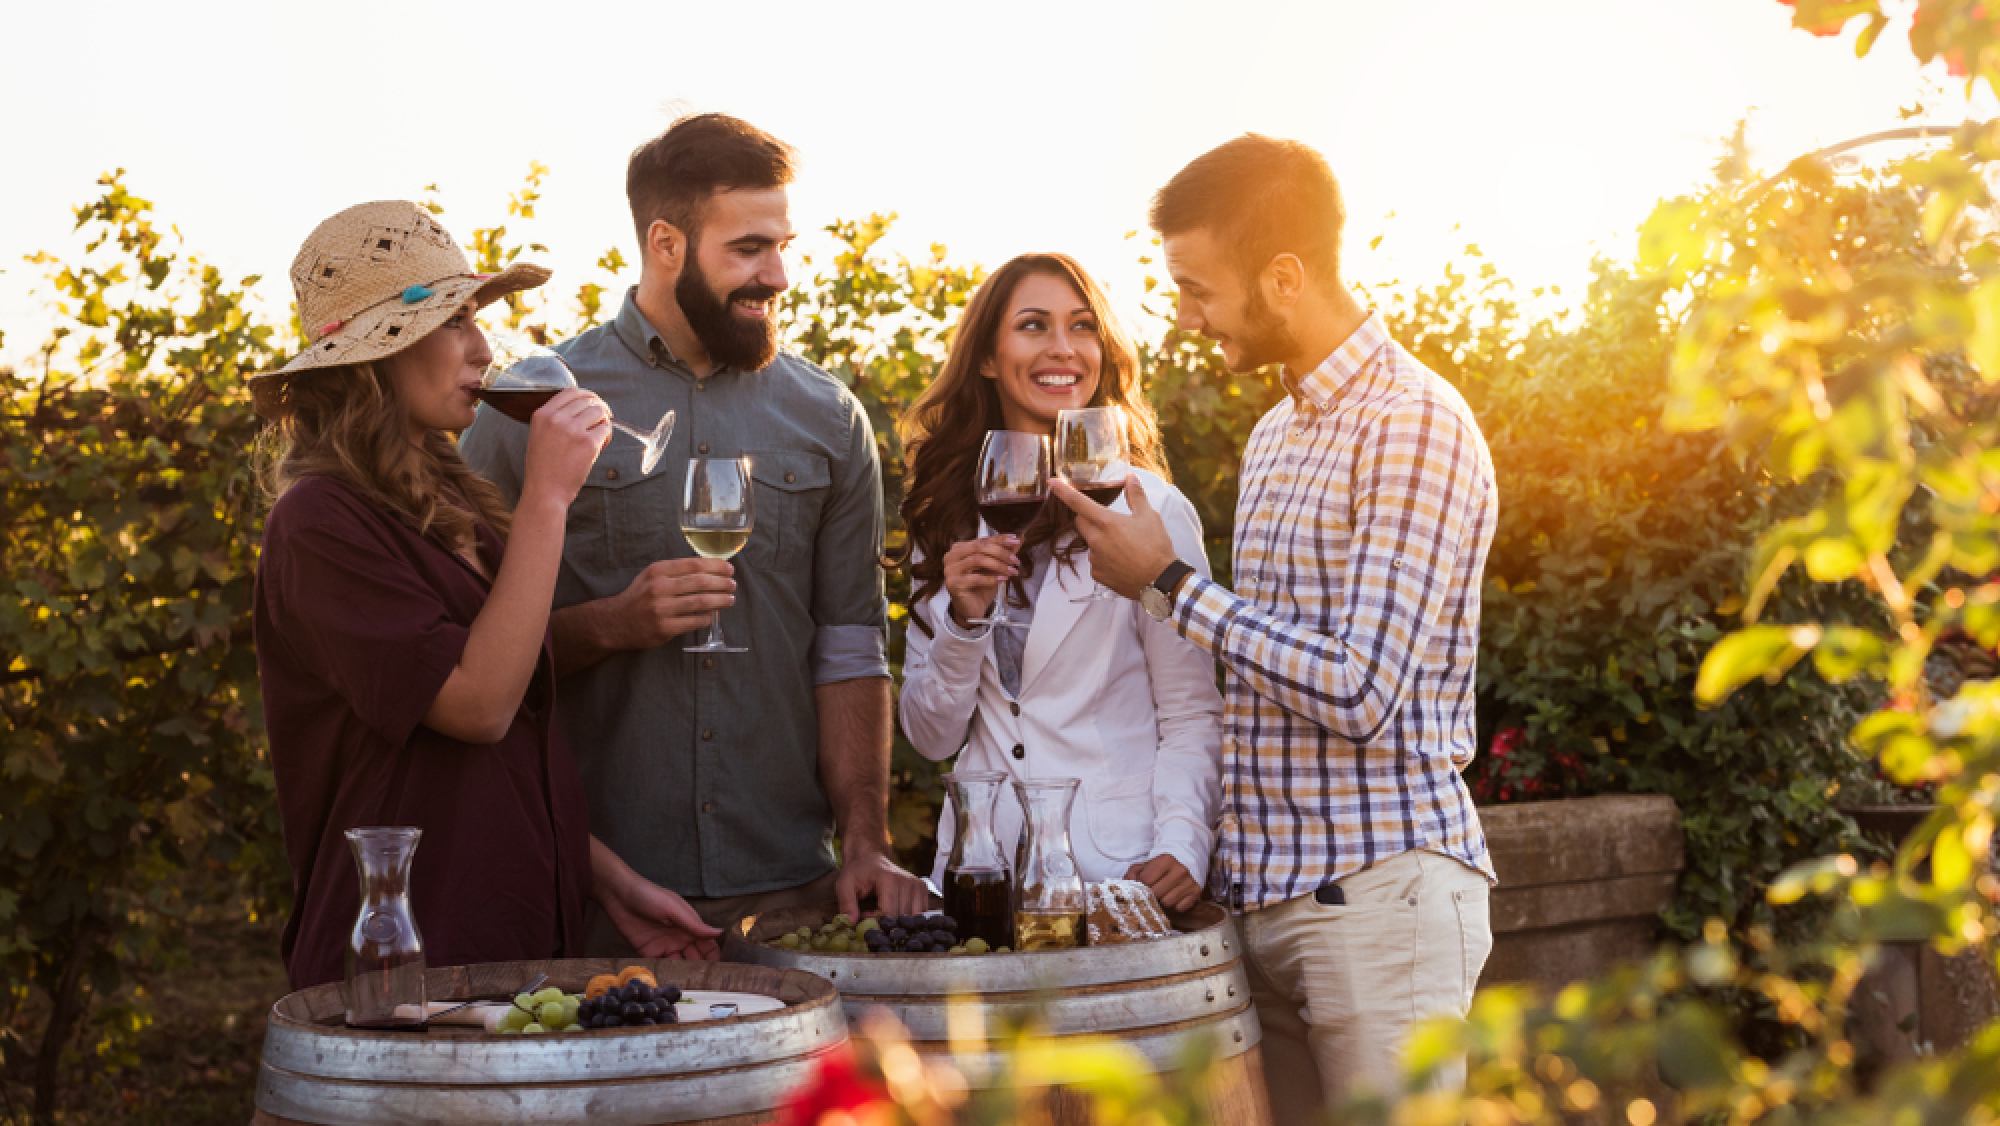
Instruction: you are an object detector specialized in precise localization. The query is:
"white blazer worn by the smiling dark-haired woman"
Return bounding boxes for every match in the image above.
[898,470,1222,888]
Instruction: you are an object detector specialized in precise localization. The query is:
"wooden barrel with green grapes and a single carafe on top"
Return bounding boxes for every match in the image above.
[254,958,848,1126]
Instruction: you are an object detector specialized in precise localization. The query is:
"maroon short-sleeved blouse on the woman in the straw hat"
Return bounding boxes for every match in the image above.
[256,478,590,988]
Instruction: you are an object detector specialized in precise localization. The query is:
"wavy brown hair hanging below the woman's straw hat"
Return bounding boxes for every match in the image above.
[256,364,512,550]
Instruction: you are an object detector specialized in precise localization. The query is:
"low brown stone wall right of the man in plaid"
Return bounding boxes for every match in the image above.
[1480,794,1682,986]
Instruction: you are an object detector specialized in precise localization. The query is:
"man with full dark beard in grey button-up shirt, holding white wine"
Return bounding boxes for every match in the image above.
[460,114,926,956]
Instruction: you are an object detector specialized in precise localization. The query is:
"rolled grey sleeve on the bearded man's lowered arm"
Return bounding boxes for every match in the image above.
[810,394,888,684]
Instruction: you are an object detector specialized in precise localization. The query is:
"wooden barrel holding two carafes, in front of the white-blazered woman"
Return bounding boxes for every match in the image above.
[722,904,1270,1126]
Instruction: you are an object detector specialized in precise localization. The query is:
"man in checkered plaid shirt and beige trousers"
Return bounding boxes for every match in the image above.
[1052,134,1498,1122]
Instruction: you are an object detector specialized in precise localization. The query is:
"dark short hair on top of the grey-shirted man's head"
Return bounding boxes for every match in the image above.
[626,114,794,252]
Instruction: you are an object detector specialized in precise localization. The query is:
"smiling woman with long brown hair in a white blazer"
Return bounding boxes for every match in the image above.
[900,254,1222,910]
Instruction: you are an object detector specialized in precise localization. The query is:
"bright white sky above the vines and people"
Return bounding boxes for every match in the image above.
[0,0,1994,370]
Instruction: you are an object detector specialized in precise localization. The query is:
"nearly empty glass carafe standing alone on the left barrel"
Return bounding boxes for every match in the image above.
[348,828,424,1028]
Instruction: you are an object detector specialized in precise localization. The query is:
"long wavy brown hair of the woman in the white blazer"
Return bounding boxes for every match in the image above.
[898,254,1168,636]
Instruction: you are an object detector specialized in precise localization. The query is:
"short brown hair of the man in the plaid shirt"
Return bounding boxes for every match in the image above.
[1148,132,1348,286]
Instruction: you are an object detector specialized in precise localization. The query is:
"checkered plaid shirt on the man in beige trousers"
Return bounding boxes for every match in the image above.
[1174,314,1498,910]
